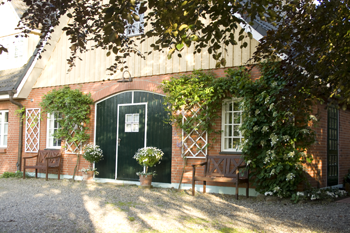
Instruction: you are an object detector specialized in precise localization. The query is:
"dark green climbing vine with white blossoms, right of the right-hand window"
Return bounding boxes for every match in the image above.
[228,63,317,197]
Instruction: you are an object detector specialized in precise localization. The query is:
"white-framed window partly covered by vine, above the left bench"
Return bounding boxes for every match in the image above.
[46,112,62,149]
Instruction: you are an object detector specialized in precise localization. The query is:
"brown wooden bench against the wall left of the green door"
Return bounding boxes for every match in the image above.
[23,150,62,180]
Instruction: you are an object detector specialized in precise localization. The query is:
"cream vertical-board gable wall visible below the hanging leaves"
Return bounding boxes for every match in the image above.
[34,21,258,88]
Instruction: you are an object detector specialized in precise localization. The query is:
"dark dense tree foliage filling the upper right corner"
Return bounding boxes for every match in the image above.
[255,0,350,109]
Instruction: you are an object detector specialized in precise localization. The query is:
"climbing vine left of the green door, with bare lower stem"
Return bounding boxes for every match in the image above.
[40,87,93,180]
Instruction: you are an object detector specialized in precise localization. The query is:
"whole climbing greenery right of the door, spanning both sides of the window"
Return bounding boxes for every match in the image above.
[163,63,317,197]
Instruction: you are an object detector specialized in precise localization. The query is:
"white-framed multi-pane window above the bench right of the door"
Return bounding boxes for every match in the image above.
[221,98,244,152]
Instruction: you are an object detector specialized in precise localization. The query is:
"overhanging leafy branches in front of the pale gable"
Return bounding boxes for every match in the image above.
[0,0,284,72]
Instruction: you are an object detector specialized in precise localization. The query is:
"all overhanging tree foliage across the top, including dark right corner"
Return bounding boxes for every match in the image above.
[0,0,350,107]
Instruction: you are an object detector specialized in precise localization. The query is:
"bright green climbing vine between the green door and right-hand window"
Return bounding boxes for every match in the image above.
[162,69,246,137]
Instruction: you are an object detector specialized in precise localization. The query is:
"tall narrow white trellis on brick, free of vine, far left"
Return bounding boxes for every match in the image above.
[25,108,40,152]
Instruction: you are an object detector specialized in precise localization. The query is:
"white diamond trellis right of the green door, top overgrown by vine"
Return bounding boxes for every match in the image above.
[181,104,208,158]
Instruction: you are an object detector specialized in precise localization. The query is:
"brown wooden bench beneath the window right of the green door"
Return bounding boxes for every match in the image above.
[192,155,249,199]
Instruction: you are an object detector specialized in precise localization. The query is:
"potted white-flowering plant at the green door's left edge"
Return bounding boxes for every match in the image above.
[80,144,103,180]
